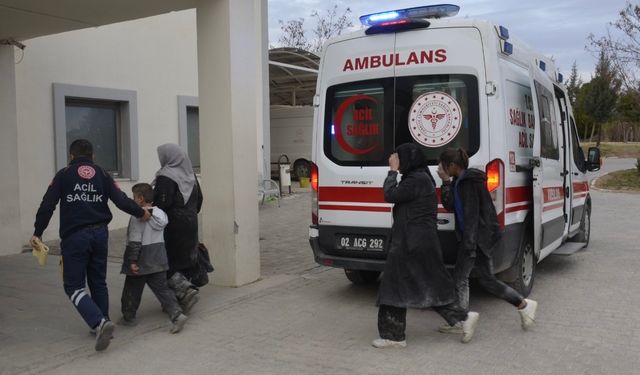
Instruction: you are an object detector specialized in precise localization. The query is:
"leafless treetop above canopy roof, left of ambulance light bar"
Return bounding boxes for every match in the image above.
[278,5,353,53]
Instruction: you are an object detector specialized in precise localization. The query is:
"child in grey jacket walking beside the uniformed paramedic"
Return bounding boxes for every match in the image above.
[120,183,187,333]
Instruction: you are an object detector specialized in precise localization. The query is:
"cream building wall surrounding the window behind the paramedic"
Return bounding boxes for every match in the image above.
[16,9,198,244]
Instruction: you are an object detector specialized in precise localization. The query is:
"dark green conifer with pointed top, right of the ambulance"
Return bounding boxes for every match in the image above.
[584,50,620,146]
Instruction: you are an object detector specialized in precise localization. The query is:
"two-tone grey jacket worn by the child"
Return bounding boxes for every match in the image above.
[120,207,169,276]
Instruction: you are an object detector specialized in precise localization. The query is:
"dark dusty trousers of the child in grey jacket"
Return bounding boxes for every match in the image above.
[120,272,182,321]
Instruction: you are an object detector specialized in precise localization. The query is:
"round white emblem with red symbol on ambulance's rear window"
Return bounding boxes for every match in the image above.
[409,91,462,148]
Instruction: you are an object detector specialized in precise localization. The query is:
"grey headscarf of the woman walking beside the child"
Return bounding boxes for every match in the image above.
[156,143,196,204]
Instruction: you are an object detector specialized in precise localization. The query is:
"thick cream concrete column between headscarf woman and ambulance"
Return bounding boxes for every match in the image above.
[197,0,267,286]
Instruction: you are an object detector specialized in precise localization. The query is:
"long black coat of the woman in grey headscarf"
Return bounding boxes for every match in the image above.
[153,176,202,272]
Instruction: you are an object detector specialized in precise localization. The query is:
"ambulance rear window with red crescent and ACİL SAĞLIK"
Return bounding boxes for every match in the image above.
[324,78,393,166]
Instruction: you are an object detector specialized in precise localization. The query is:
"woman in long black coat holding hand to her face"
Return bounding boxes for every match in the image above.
[372,143,476,348]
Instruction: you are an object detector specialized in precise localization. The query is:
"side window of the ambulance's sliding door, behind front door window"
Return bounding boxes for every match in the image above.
[536,82,560,160]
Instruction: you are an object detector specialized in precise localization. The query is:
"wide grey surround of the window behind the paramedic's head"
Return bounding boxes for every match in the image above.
[53,83,140,180]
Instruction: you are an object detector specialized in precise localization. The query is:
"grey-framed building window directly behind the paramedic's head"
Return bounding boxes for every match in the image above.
[53,83,138,180]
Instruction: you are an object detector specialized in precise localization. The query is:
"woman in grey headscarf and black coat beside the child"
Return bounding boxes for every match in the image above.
[153,143,202,312]
